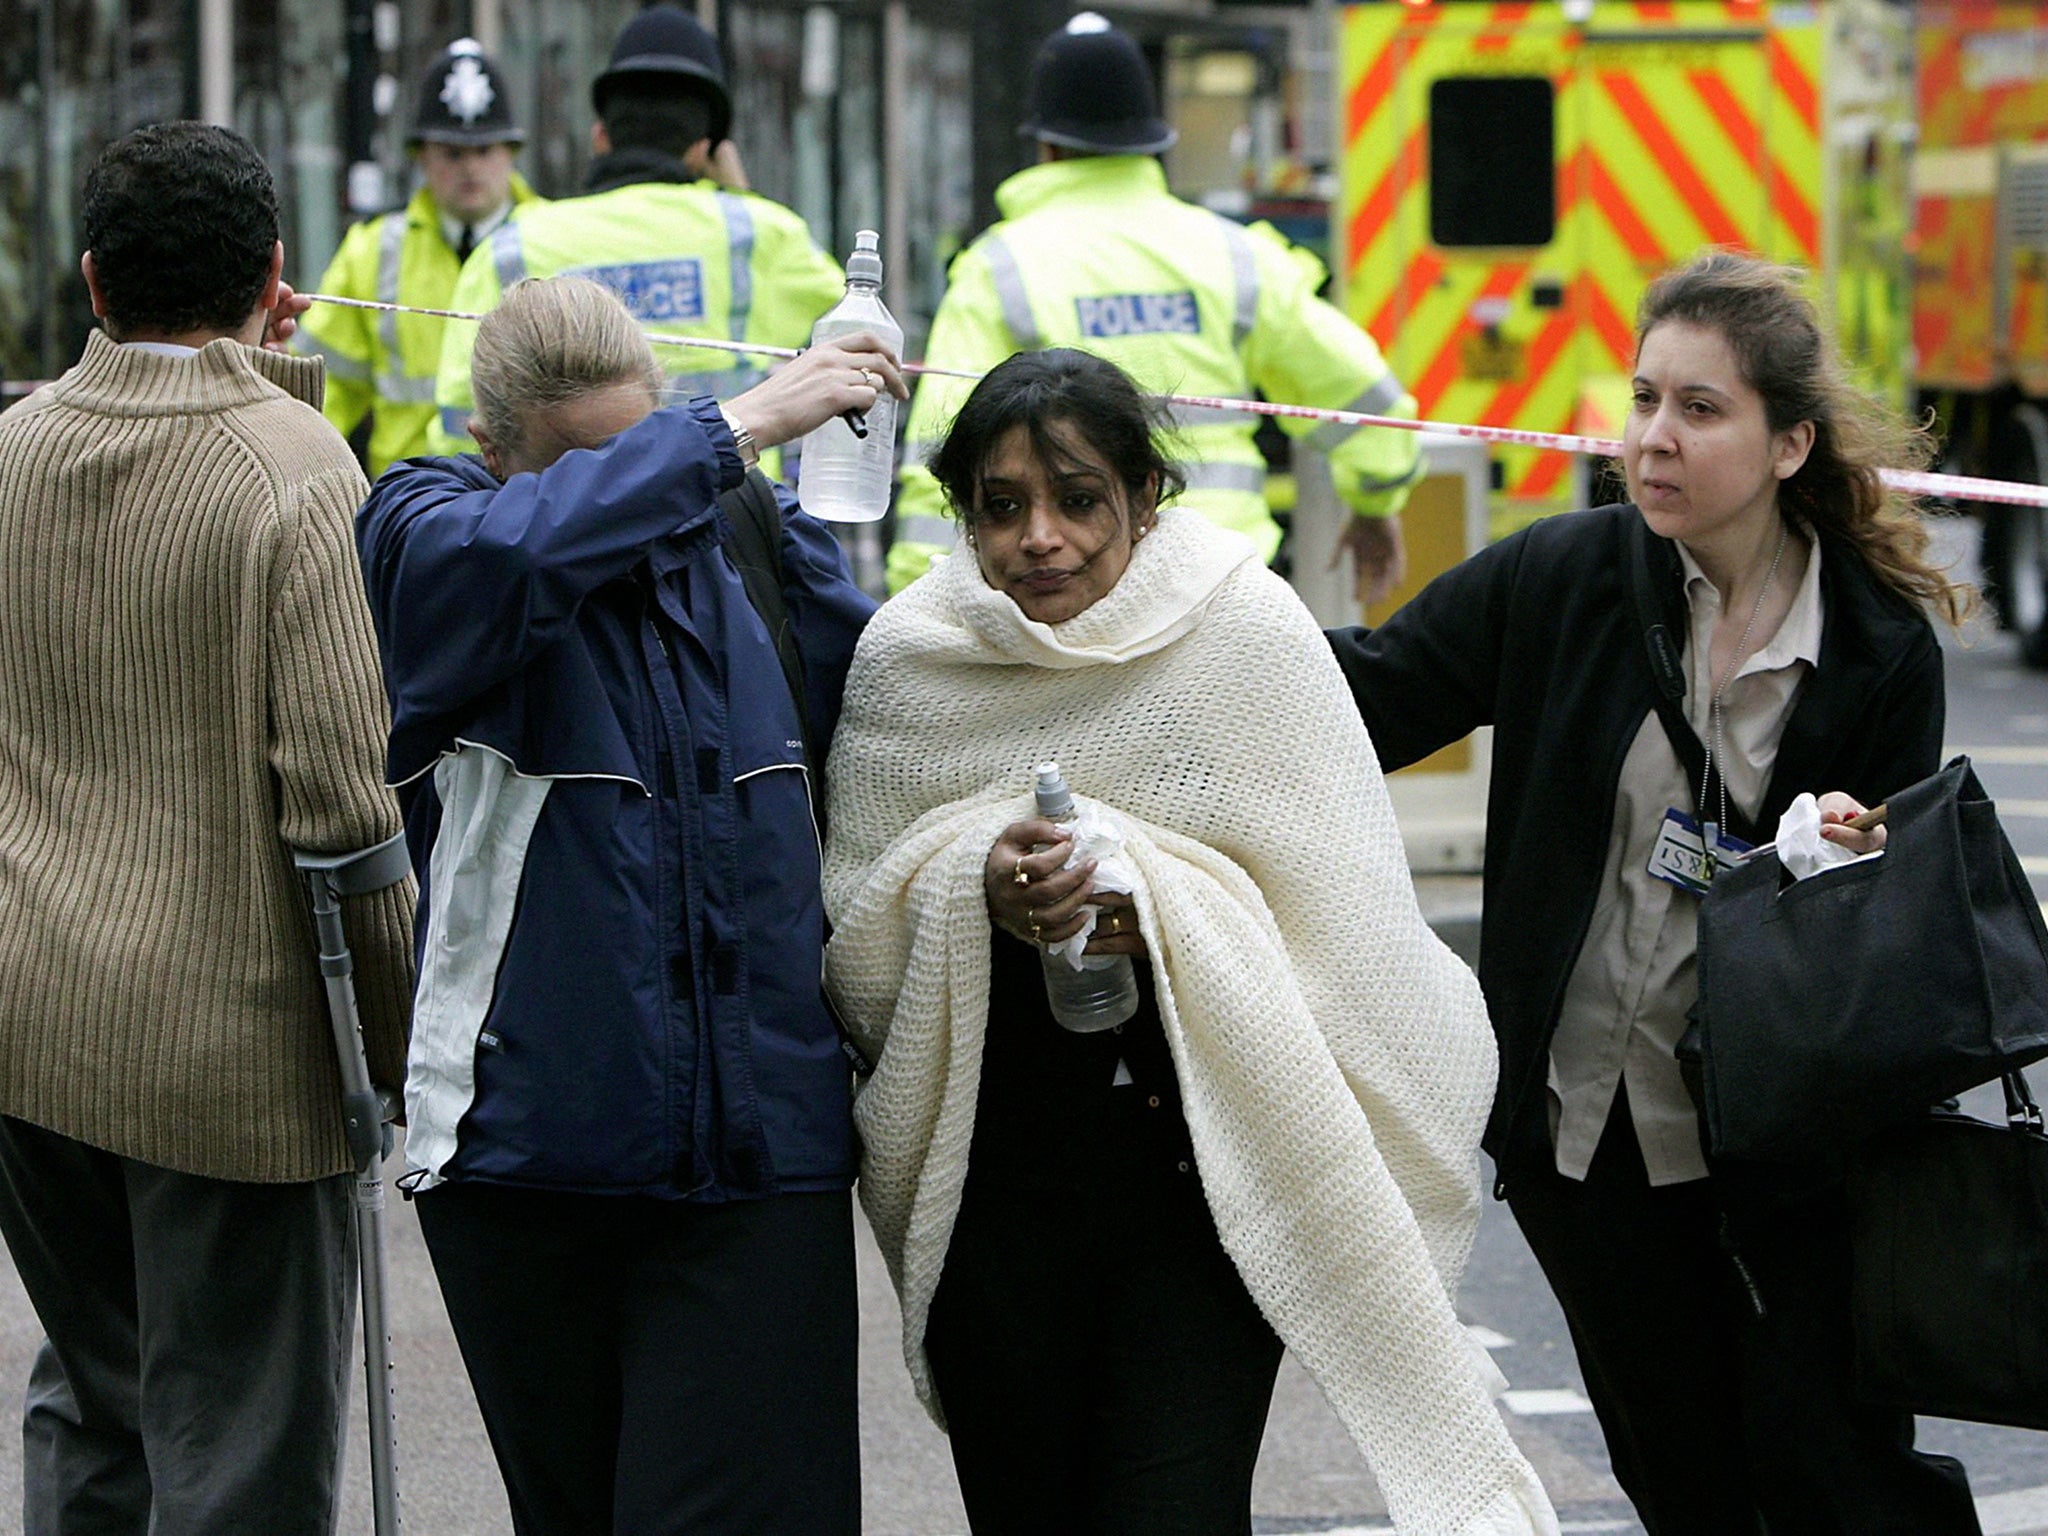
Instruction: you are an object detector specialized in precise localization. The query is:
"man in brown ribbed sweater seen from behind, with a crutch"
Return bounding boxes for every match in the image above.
[0,123,412,1536]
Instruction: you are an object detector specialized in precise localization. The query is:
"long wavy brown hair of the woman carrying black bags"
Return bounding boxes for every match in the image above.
[1636,250,1976,625]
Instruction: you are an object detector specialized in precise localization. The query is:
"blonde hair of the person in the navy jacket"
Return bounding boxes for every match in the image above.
[469,276,666,453]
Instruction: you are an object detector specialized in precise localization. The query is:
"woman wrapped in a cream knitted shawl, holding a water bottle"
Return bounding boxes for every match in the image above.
[825,350,1556,1536]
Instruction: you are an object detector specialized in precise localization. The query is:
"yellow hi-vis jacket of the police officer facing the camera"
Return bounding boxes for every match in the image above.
[293,176,541,479]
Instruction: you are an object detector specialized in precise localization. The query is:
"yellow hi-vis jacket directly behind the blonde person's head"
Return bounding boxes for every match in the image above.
[434,180,846,453]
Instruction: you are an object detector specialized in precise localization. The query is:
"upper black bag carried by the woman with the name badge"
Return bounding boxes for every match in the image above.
[1696,758,2048,1169]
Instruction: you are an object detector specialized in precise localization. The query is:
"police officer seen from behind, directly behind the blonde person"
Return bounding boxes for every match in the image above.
[434,4,846,453]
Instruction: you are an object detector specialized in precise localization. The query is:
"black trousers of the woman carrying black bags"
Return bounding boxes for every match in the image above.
[1507,1094,1978,1536]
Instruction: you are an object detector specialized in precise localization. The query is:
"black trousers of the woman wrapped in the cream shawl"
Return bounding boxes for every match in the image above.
[926,1174,1280,1536]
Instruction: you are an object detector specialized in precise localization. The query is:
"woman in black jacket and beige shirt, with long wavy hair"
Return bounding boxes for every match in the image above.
[1331,252,1978,1536]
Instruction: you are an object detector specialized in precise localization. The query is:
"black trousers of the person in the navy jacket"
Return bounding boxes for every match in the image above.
[418,1182,860,1536]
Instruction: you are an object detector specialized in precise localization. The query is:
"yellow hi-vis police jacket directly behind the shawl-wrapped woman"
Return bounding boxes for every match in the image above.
[889,156,1421,590]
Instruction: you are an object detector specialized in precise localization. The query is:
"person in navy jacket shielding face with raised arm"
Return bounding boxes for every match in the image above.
[356,276,903,1536]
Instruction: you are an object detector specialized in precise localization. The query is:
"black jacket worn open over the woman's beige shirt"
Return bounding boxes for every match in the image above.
[1329,506,1944,1194]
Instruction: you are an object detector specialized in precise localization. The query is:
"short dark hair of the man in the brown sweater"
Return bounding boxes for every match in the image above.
[84,123,279,332]
